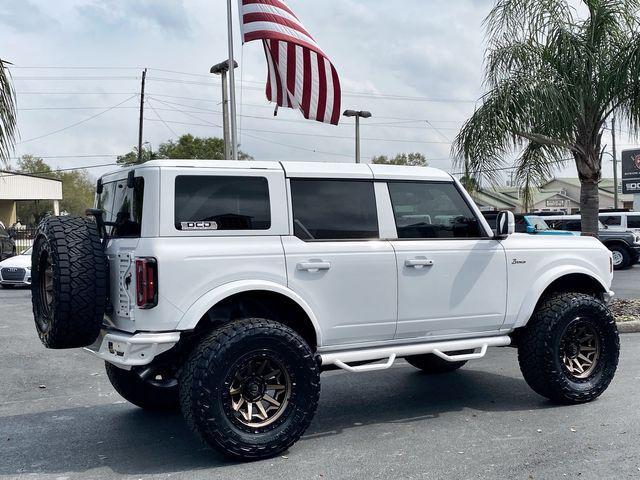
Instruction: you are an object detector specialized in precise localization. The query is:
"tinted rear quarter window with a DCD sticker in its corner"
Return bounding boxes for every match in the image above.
[175,175,271,230]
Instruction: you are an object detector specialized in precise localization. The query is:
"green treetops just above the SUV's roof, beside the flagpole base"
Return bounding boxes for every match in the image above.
[118,134,253,165]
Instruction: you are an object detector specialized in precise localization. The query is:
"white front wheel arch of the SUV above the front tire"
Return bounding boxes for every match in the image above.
[513,267,609,328]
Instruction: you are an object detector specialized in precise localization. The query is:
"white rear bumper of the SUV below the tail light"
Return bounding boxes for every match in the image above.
[85,330,180,368]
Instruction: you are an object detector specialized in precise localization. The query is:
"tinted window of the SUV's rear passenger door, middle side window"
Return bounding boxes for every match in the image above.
[291,179,379,240]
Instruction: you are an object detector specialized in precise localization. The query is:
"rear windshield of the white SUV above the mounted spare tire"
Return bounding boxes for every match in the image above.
[96,177,144,238]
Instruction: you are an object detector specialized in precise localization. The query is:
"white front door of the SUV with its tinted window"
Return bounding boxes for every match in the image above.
[388,182,507,339]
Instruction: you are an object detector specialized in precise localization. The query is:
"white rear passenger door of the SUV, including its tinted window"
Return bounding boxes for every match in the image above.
[282,174,397,346]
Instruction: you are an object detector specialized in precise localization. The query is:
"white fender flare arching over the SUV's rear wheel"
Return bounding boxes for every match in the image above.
[176,280,322,346]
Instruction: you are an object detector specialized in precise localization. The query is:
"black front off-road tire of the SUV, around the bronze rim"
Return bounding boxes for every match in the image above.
[518,293,620,404]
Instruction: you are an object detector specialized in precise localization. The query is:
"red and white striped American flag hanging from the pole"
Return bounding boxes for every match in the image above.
[239,0,341,125]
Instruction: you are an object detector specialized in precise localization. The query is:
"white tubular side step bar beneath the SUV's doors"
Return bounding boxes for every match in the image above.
[320,335,511,373]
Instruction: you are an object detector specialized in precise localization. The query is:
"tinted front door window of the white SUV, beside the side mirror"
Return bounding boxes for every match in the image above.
[388,182,485,238]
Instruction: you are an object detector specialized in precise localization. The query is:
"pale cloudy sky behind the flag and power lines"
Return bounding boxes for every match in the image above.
[0,0,632,180]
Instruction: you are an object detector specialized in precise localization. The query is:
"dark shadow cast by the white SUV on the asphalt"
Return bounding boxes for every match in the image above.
[0,365,552,476]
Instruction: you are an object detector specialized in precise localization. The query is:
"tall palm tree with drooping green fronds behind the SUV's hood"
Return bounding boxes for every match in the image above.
[453,0,640,235]
